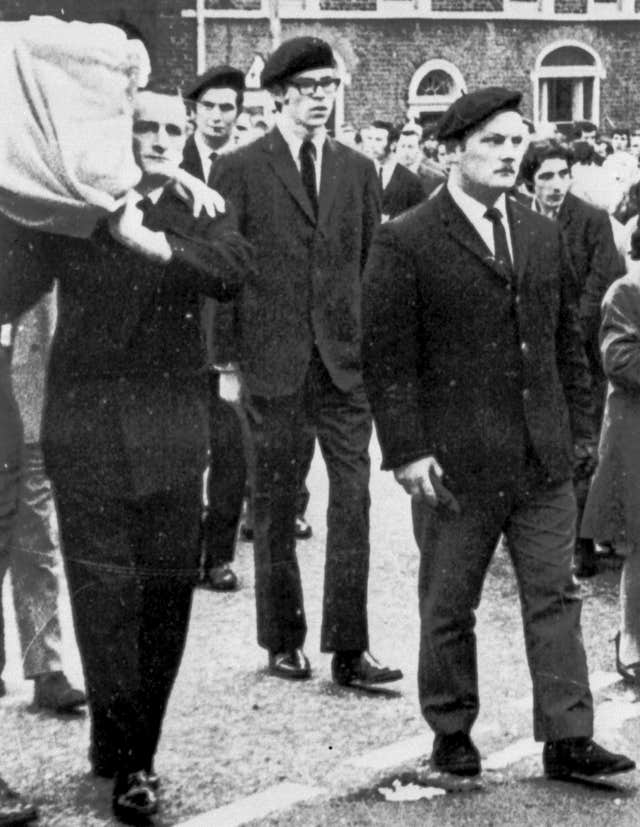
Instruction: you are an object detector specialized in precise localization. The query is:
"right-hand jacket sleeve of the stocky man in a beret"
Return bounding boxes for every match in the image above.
[555,239,594,441]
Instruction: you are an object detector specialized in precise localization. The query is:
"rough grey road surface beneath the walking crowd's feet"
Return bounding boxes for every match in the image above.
[0,436,640,827]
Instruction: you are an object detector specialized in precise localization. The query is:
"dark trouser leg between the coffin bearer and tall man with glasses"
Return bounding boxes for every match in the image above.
[202,371,248,571]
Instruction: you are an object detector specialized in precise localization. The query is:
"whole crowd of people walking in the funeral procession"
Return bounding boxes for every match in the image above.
[0,19,640,824]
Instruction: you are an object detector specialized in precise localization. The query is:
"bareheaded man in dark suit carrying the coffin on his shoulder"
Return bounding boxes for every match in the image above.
[0,91,250,823]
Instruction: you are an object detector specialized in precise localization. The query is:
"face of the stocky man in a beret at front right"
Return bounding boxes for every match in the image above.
[454,112,528,200]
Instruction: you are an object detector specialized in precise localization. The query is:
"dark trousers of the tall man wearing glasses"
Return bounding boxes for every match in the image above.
[251,354,371,652]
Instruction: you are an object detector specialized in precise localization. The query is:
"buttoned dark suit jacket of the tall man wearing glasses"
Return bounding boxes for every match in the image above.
[213,128,380,397]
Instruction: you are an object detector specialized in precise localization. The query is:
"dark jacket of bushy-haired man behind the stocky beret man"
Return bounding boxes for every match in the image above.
[558,193,624,366]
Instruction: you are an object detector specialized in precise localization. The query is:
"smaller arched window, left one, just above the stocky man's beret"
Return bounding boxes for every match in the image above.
[407,60,466,123]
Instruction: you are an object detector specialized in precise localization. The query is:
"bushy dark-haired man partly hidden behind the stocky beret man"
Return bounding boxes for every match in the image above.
[521,138,624,576]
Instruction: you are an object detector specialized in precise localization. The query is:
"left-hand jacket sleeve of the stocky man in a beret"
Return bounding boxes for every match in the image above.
[362,224,432,469]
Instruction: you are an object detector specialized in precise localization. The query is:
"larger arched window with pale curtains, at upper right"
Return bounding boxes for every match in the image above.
[531,40,606,125]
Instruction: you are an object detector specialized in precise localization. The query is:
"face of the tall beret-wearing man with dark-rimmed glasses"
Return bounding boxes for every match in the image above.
[277,67,339,132]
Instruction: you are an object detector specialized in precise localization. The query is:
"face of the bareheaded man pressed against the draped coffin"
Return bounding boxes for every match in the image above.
[133,92,187,185]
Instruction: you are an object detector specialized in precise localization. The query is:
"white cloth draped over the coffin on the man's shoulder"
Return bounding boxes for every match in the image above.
[0,17,148,236]
